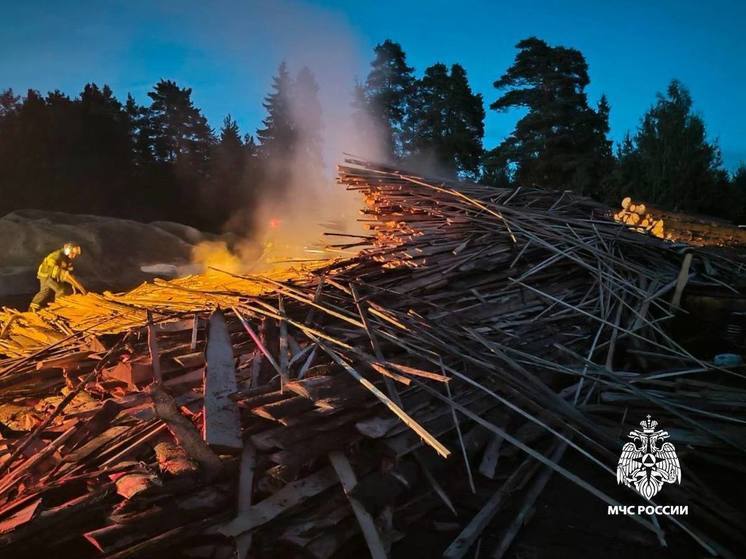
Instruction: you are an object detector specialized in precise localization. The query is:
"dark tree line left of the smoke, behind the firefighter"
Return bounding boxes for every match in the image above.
[0,64,323,233]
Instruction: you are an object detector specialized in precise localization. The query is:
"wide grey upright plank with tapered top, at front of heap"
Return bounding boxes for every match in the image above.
[203,310,243,452]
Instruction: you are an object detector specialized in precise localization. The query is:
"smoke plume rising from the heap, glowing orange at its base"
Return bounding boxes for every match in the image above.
[186,2,384,271]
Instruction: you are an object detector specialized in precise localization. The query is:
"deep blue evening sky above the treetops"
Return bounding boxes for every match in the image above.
[0,0,746,170]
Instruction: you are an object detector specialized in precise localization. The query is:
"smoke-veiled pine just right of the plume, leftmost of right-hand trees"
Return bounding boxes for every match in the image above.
[353,39,415,158]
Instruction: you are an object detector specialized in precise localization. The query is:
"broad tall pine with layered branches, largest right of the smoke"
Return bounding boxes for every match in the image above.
[488,37,611,194]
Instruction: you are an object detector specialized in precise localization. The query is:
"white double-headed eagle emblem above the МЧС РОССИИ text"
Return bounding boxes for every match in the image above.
[616,415,681,500]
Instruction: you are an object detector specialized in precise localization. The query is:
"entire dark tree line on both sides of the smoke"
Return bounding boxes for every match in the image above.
[0,37,746,232]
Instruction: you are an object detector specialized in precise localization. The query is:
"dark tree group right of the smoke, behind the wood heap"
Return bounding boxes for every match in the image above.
[354,37,746,222]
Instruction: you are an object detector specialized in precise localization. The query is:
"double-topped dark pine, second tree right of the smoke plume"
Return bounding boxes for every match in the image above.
[404,64,484,179]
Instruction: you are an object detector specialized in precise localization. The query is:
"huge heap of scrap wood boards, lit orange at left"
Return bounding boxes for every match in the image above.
[0,159,746,559]
